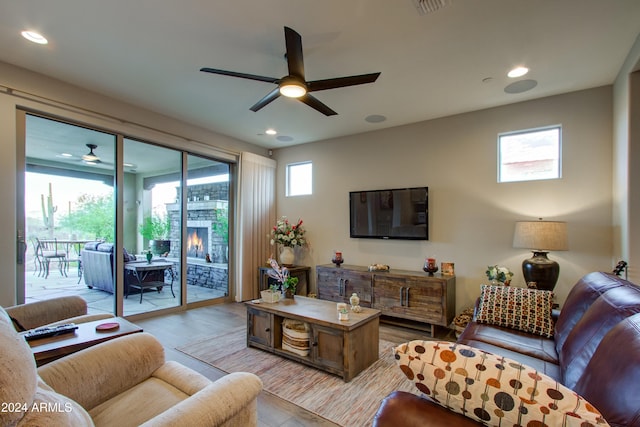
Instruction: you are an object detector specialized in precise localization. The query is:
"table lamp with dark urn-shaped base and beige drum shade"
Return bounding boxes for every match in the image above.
[513,218,569,291]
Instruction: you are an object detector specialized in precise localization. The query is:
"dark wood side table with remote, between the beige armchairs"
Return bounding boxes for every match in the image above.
[24,317,142,366]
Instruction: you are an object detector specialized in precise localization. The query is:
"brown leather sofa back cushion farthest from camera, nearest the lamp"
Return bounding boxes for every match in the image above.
[554,272,629,353]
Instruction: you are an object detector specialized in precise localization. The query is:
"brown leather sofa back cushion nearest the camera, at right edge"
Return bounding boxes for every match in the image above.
[574,314,640,427]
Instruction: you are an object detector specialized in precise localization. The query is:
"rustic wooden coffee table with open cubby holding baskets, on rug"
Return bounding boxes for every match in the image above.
[246,295,380,382]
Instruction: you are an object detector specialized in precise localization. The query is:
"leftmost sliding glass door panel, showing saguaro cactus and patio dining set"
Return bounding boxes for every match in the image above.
[18,115,116,313]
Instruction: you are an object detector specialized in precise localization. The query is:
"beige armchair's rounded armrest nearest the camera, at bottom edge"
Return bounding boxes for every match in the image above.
[142,372,262,427]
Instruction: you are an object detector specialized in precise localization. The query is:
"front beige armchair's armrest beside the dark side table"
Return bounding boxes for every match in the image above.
[38,332,164,411]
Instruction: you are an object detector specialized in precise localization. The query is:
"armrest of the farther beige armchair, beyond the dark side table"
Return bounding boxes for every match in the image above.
[5,296,87,329]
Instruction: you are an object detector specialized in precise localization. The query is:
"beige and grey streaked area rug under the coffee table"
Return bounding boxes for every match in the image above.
[177,327,422,427]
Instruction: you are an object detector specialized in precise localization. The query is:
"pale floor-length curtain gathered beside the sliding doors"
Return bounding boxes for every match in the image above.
[235,152,276,301]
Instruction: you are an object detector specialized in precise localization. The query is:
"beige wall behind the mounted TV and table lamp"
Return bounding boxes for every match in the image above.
[274,86,615,309]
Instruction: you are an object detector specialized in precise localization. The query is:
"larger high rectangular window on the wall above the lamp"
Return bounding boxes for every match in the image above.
[498,126,562,182]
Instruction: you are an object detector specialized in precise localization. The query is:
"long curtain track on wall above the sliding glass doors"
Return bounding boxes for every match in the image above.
[0,83,240,156]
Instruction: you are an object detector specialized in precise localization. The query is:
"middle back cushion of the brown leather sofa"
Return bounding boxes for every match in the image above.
[558,285,640,388]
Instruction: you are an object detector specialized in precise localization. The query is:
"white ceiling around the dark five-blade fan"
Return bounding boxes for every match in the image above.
[0,0,640,148]
